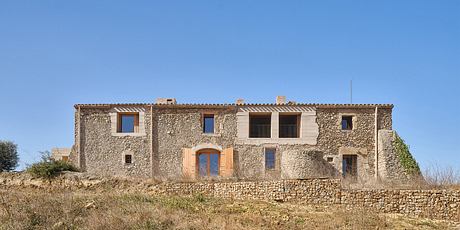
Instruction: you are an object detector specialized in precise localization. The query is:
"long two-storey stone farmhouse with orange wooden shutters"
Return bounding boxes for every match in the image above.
[70,96,405,181]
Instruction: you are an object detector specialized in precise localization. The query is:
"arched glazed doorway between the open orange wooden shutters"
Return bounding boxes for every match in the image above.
[197,151,220,177]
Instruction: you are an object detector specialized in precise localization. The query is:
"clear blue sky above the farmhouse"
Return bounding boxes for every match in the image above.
[0,0,460,169]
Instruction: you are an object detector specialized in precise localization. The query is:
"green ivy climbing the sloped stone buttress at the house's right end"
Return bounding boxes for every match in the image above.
[393,133,421,175]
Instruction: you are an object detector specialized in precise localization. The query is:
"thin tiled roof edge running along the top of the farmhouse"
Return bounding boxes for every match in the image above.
[74,103,394,108]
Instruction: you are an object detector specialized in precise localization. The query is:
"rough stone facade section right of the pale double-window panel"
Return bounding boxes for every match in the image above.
[317,108,392,181]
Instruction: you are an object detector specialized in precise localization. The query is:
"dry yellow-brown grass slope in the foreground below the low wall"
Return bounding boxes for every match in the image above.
[0,189,454,230]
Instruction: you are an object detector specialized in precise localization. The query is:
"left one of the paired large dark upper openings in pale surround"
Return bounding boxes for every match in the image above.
[249,114,272,138]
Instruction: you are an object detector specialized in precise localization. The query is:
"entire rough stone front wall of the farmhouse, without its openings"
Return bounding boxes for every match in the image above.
[71,105,398,180]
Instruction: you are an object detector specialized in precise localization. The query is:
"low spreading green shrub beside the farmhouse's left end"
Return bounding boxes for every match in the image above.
[26,152,78,179]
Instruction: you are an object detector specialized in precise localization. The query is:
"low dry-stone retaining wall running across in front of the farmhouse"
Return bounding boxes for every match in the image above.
[0,173,460,221]
